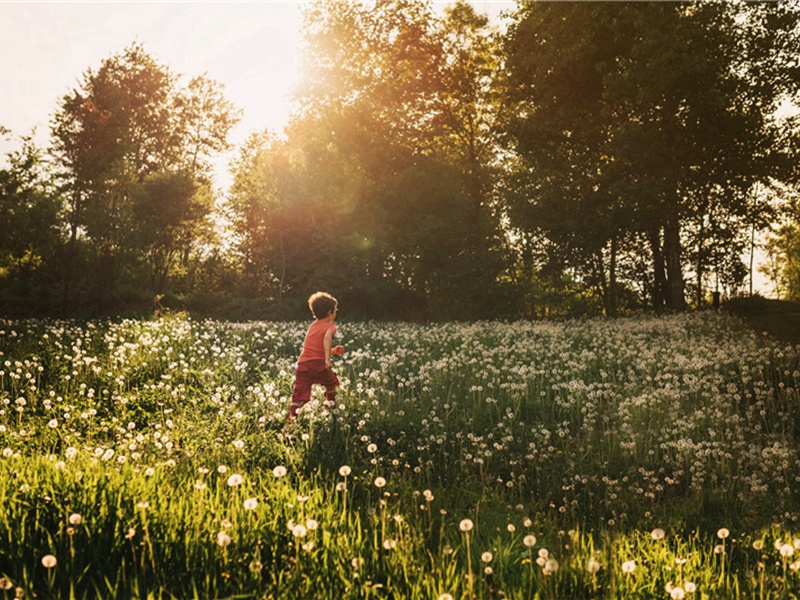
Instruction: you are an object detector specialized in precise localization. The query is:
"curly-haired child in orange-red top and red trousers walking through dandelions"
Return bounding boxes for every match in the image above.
[286,292,344,422]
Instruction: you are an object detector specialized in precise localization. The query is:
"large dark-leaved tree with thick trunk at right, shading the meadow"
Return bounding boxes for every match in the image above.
[507,2,797,309]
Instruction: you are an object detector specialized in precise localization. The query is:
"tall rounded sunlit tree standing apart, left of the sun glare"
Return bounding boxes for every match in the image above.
[47,44,239,308]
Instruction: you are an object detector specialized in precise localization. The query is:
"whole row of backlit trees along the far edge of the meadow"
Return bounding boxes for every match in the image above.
[0,0,800,319]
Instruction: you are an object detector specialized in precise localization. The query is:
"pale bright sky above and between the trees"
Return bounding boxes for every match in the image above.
[0,0,770,294]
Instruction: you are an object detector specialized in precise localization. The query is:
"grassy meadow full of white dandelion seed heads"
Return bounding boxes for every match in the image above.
[0,312,800,600]
